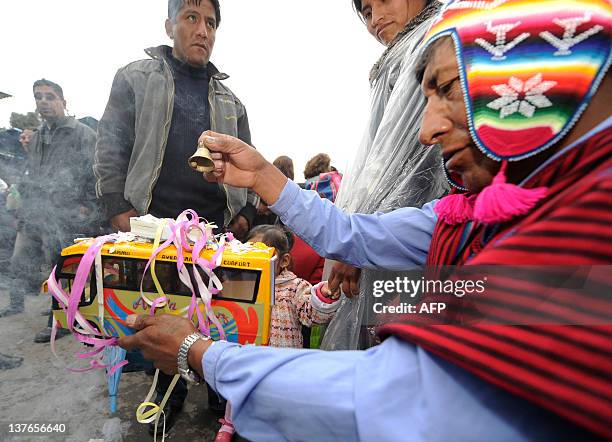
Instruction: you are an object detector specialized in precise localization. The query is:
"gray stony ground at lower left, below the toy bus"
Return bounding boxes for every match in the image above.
[0,287,234,442]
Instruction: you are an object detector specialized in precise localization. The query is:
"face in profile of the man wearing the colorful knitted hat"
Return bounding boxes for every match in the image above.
[419,40,500,193]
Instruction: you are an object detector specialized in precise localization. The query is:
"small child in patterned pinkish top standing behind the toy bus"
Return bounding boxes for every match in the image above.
[215,225,338,442]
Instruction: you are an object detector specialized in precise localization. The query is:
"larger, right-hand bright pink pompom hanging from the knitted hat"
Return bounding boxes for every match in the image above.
[474,161,548,224]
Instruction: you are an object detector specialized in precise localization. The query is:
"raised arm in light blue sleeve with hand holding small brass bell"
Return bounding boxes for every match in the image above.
[200,131,437,270]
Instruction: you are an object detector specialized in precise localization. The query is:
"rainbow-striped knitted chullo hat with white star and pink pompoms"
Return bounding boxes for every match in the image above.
[425,0,612,224]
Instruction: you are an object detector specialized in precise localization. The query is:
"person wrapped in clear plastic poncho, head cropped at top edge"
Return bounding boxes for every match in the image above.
[321,0,448,350]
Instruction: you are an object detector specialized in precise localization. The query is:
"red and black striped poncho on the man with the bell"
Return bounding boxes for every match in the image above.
[379,127,612,438]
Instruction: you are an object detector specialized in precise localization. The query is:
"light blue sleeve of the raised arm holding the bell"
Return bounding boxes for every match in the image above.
[270,181,437,270]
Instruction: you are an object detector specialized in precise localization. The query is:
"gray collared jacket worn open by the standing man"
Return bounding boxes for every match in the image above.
[94,46,258,225]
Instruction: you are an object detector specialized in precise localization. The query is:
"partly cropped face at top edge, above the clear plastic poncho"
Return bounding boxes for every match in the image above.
[361,0,426,45]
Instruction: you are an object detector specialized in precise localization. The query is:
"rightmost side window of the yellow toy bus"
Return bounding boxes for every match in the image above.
[197,267,261,303]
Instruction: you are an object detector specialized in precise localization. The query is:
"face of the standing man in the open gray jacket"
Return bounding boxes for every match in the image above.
[166,0,217,67]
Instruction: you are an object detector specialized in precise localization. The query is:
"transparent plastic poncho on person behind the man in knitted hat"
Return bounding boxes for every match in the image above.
[321,18,448,350]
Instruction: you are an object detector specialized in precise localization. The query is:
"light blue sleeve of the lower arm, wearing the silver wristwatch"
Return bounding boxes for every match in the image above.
[202,338,586,442]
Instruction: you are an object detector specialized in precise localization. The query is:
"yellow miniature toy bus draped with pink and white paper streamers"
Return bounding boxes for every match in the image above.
[53,240,276,345]
